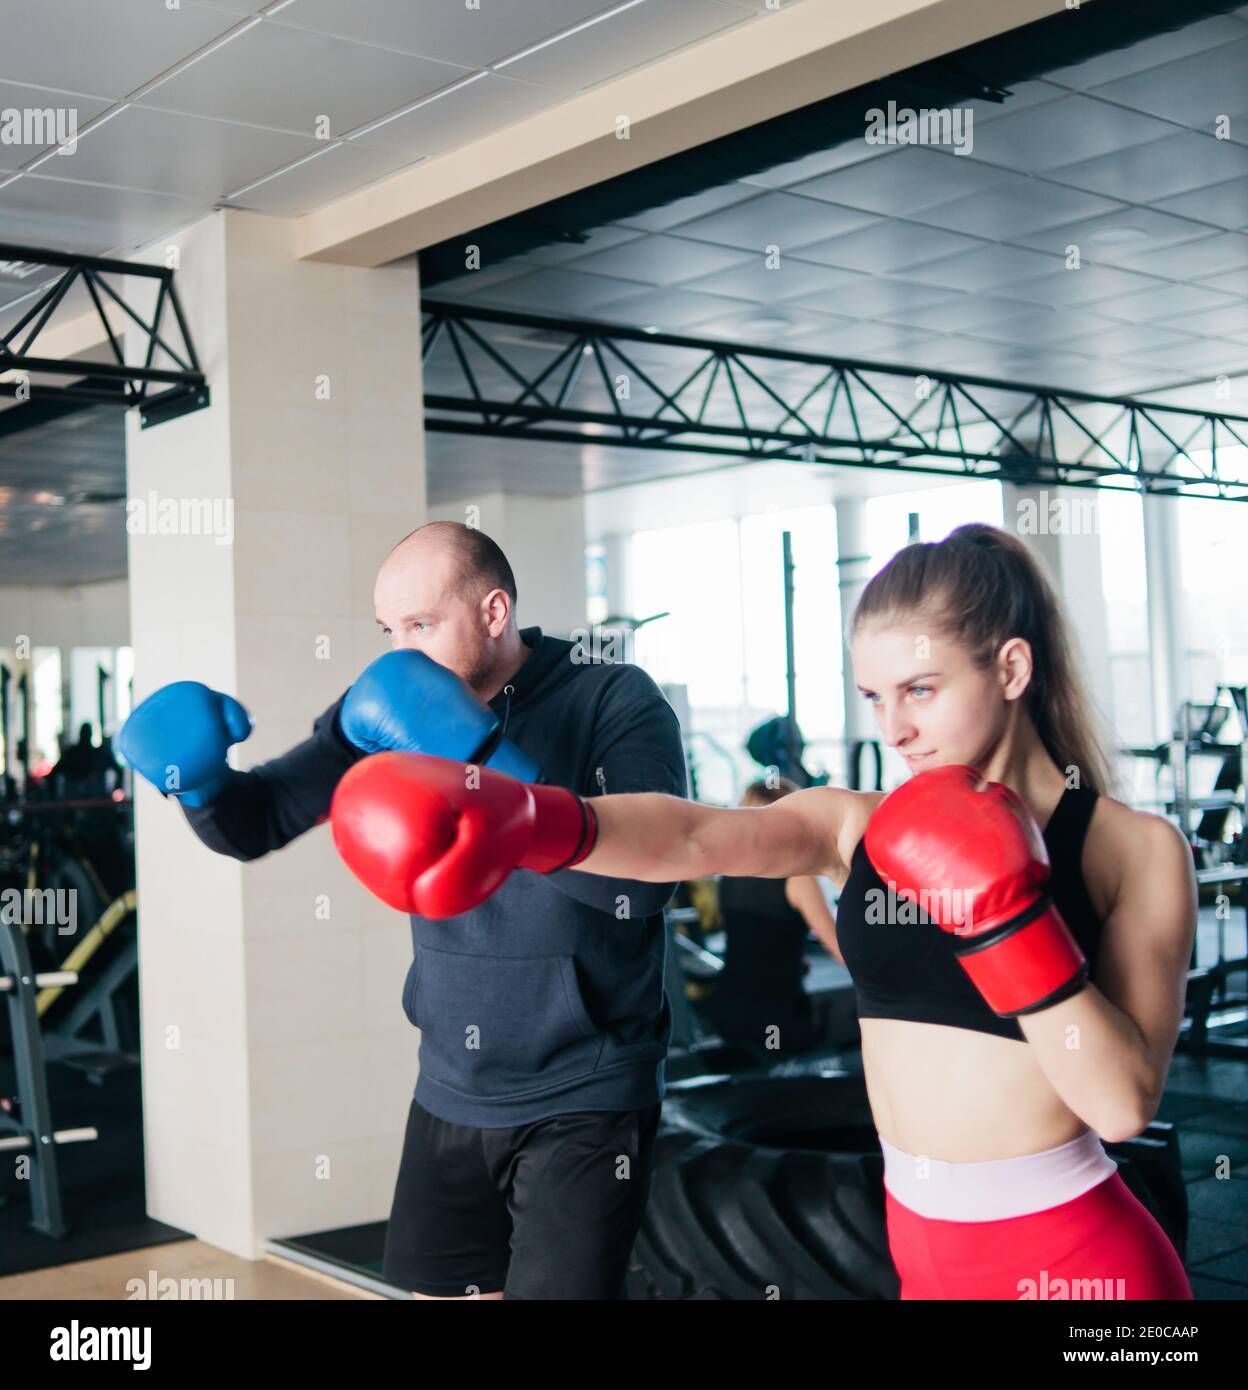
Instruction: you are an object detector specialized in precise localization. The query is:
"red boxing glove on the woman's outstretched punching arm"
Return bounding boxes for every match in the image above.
[329,752,598,917]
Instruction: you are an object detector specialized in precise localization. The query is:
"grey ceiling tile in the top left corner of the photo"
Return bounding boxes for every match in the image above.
[0,0,239,100]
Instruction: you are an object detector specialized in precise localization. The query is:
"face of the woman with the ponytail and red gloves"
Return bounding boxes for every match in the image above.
[852,624,1030,773]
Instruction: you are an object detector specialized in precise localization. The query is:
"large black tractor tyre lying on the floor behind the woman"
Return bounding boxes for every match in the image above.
[630,1069,1188,1300]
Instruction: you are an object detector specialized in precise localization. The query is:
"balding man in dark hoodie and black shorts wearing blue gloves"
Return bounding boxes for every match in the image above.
[122,523,685,1298]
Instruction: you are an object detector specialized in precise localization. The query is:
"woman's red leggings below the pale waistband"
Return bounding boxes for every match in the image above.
[885,1173,1192,1300]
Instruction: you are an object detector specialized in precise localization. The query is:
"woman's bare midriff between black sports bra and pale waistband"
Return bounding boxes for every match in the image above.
[862,1019,1088,1163]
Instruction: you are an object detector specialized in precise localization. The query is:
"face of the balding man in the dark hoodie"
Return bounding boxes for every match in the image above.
[372,545,492,689]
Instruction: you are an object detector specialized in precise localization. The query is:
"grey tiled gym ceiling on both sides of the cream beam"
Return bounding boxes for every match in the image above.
[0,0,1248,584]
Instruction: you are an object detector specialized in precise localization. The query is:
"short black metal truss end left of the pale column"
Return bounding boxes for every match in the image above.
[0,243,210,428]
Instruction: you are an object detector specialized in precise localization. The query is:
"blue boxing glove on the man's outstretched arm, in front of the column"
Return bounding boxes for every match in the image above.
[117,681,252,806]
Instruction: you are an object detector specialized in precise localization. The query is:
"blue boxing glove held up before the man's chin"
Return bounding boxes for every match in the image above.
[339,648,542,783]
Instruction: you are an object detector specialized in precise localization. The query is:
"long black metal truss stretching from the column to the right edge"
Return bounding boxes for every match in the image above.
[422,300,1248,502]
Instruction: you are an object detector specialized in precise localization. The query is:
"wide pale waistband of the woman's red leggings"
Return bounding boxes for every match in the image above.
[880,1130,1117,1220]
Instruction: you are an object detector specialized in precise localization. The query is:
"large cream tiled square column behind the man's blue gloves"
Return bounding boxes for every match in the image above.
[126,211,425,1258]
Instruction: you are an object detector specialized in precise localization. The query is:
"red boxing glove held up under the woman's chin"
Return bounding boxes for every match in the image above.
[866,765,1088,1019]
